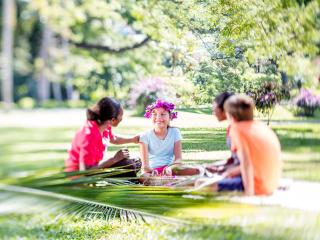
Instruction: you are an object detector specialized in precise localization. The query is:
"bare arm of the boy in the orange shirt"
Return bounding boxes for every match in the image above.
[238,148,254,196]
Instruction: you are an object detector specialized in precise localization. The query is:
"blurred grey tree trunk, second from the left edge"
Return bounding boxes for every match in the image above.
[37,24,52,103]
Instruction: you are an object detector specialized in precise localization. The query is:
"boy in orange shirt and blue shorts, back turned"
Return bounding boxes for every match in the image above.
[196,95,282,195]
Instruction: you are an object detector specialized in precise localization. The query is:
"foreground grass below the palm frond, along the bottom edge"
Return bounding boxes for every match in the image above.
[0,187,320,240]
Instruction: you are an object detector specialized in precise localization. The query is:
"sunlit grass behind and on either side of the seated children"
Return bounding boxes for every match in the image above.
[0,123,320,181]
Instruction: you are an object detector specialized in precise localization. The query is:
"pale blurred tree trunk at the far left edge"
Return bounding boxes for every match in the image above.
[2,0,16,111]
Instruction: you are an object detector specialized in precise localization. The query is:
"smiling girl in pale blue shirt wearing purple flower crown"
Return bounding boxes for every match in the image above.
[140,99,199,175]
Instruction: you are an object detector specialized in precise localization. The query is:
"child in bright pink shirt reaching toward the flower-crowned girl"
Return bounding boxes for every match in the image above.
[66,97,139,176]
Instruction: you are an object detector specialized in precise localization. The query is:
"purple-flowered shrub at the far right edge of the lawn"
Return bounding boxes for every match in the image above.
[293,89,320,117]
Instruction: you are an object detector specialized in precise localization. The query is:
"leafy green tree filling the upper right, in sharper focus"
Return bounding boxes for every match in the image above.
[154,0,320,106]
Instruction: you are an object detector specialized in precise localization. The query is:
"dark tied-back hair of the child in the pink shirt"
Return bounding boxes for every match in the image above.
[87,97,121,125]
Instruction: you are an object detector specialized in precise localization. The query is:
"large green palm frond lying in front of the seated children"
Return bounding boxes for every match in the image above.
[0,169,250,223]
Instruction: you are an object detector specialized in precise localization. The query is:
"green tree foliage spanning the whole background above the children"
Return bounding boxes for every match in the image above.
[7,0,320,106]
